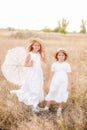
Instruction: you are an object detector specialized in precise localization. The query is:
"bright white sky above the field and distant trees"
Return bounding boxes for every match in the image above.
[0,0,87,31]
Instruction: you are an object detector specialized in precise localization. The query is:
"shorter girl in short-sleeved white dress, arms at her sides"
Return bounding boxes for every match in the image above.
[44,48,71,116]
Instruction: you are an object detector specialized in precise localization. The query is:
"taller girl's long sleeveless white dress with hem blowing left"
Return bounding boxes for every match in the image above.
[11,52,44,107]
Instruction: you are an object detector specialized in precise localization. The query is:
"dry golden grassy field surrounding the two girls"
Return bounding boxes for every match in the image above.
[0,30,87,130]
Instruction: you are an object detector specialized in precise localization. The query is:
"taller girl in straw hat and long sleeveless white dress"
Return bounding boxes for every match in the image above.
[10,38,45,112]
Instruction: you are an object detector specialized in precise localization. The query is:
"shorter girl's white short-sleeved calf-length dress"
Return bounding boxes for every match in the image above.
[45,61,71,103]
